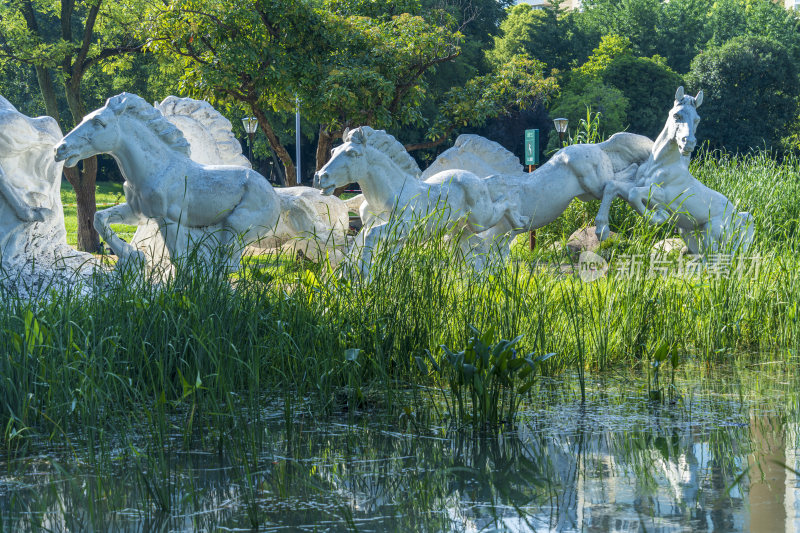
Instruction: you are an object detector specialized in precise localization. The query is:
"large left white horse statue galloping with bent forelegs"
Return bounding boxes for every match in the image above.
[56,93,280,268]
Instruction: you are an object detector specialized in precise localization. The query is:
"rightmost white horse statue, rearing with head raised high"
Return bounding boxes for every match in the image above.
[597,87,755,254]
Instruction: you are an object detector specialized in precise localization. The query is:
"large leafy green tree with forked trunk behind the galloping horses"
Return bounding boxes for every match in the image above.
[148,0,552,179]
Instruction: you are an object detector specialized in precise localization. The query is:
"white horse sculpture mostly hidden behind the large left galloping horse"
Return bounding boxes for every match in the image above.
[130,96,350,264]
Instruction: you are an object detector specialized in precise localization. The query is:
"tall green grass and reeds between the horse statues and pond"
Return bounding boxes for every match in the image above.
[0,154,800,448]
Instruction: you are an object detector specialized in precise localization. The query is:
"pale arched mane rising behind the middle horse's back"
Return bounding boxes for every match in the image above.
[420,134,524,180]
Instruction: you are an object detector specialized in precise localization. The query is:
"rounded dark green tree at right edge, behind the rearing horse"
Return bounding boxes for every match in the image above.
[687,36,798,151]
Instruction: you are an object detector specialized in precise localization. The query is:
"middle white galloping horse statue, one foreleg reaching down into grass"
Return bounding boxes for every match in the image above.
[315,126,527,276]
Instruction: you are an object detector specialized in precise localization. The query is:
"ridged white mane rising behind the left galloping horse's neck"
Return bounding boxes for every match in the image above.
[155,96,247,168]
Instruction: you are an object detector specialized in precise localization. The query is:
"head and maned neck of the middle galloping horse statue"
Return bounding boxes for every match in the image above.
[314,126,420,195]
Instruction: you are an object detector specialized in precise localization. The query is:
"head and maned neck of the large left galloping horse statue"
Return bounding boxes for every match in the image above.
[56,93,190,167]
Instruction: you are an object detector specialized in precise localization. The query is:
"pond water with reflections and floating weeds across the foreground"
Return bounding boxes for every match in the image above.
[0,365,800,532]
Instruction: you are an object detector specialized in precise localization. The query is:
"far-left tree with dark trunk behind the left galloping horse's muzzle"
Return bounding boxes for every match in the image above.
[0,0,141,251]
